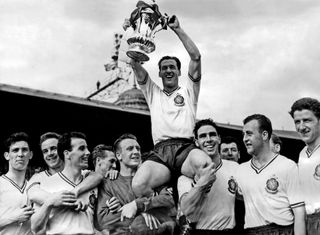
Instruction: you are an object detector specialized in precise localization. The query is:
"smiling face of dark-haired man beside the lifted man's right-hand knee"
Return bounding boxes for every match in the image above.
[196,125,220,157]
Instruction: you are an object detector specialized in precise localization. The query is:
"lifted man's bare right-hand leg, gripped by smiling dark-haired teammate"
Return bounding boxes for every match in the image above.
[181,148,212,178]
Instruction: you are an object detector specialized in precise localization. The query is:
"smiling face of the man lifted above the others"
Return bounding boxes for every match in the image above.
[159,59,181,89]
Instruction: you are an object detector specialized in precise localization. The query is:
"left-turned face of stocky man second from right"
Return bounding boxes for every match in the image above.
[243,120,267,155]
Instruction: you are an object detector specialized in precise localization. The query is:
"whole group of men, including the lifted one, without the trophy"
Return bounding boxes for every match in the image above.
[0,13,320,235]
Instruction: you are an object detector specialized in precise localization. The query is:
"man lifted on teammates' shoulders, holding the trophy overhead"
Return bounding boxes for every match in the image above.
[127,1,212,200]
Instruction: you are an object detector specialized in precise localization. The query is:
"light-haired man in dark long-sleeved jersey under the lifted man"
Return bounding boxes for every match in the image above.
[96,134,175,235]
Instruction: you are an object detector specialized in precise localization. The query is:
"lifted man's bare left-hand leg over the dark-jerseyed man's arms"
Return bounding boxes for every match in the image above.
[132,160,171,197]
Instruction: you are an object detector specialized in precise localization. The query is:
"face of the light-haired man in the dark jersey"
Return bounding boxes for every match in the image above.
[117,139,141,168]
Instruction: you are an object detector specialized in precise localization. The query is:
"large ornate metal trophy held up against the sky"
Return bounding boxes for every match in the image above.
[124,1,167,62]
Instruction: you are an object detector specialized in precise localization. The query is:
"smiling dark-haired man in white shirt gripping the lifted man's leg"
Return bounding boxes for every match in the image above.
[178,119,238,235]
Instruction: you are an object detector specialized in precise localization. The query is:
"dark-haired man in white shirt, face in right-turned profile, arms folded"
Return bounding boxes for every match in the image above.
[31,132,96,234]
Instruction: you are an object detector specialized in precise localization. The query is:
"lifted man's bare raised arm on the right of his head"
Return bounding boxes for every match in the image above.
[168,15,201,80]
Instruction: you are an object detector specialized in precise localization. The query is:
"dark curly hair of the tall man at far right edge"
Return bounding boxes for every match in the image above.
[289,97,320,119]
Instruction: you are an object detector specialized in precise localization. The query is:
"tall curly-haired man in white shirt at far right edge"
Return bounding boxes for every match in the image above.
[290,98,320,235]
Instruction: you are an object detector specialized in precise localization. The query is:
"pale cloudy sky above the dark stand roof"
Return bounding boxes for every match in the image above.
[0,0,320,130]
